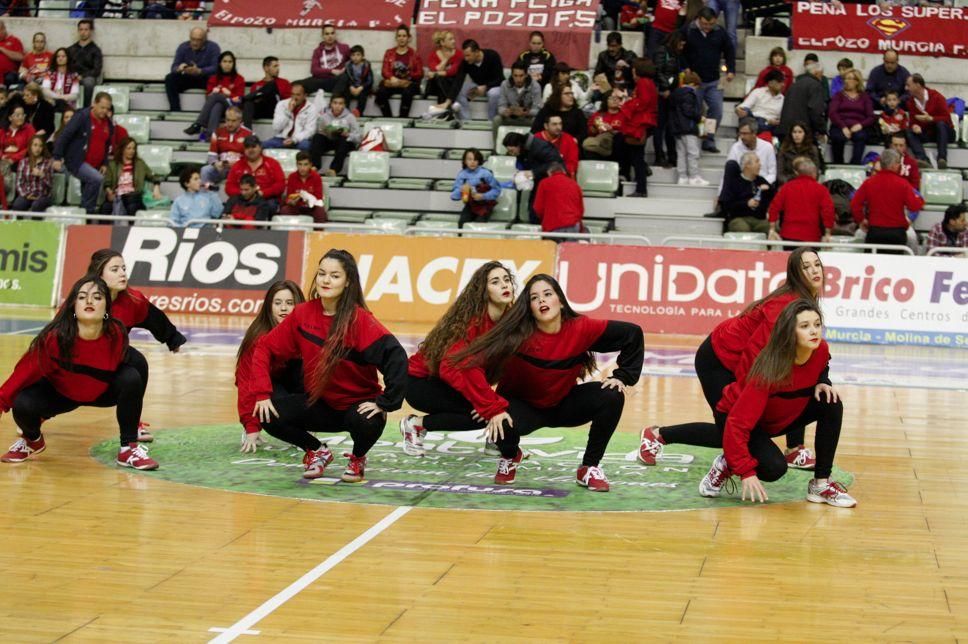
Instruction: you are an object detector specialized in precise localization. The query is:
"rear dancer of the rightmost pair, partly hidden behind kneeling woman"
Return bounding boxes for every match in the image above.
[639,246,824,470]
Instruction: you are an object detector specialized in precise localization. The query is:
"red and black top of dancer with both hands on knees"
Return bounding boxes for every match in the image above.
[252,300,407,411]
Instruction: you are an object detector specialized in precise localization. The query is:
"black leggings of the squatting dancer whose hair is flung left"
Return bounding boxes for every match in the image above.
[497,382,625,465]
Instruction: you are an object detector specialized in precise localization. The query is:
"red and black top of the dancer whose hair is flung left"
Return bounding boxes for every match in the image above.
[497,315,645,409]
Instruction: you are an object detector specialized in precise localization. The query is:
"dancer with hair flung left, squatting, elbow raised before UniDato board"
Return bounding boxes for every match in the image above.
[449,274,644,492]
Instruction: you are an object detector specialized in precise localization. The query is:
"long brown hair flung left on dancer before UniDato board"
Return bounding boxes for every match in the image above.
[449,273,596,382]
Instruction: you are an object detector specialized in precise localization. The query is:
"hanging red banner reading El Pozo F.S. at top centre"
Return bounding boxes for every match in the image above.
[417,0,599,69]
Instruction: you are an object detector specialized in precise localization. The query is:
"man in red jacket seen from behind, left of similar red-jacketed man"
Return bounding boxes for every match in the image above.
[769,157,834,242]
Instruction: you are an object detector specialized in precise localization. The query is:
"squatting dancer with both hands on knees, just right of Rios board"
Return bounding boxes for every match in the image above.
[252,249,407,483]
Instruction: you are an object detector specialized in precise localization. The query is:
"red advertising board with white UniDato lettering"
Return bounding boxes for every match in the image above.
[558,244,786,335]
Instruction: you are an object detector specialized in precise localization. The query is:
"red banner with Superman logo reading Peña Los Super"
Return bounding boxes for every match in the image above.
[793,2,968,58]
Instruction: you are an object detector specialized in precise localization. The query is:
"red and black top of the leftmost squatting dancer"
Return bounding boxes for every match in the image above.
[0,327,128,412]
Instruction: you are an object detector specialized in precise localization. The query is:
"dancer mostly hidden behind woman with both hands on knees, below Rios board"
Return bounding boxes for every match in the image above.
[235,280,306,454]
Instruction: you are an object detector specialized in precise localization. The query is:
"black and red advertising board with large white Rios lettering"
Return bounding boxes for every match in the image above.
[61,226,304,316]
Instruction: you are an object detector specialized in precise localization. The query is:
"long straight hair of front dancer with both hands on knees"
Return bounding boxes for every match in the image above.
[309,248,369,404]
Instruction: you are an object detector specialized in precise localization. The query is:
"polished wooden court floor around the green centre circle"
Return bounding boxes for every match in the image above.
[0,311,968,642]
